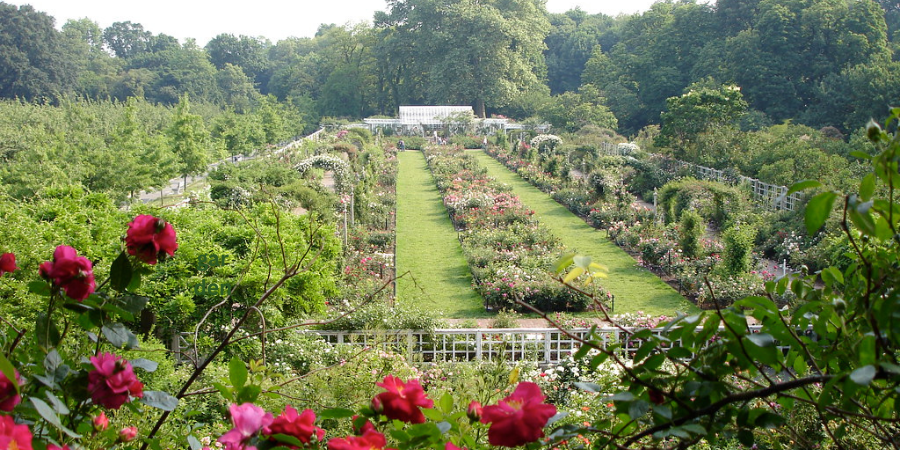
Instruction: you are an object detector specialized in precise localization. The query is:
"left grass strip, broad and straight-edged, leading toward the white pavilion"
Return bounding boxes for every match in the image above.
[396,152,489,318]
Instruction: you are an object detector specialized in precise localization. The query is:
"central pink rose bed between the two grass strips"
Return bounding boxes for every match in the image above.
[426,148,588,311]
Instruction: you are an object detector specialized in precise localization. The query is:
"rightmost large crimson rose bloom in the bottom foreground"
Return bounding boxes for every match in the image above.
[481,381,556,447]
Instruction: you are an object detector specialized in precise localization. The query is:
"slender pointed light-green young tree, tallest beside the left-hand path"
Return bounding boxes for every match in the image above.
[167,95,210,188]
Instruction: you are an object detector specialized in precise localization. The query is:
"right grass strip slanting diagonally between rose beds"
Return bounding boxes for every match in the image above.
[468,150,698,315]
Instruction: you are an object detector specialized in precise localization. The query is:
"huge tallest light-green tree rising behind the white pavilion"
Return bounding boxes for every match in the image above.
[376,0,550,117]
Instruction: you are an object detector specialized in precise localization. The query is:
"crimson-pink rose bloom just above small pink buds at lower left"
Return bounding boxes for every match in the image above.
[88,353,144,409]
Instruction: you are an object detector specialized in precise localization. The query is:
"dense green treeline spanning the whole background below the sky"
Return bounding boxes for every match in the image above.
[0,0,900,134]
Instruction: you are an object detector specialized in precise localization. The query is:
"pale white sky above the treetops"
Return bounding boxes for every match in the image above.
[14,0,654,47]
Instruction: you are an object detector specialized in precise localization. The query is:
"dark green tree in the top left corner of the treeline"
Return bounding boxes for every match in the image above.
[0,3,78,100]
